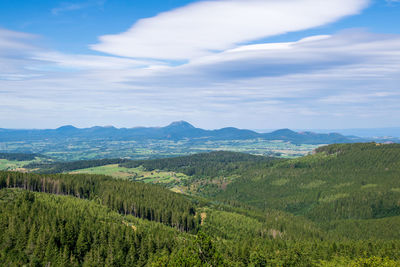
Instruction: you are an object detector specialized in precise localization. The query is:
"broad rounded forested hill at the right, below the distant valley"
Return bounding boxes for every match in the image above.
[216,143,400,227]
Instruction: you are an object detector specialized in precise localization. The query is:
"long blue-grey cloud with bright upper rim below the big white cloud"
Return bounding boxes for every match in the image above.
[118,30,400,86]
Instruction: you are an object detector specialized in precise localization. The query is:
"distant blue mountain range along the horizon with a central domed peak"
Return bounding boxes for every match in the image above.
[0,121,376,144]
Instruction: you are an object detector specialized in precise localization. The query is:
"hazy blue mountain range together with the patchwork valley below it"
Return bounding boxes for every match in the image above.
[0,121,400,161]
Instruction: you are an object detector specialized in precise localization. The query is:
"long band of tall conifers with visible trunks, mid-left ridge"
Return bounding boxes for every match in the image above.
[0,172,198,231]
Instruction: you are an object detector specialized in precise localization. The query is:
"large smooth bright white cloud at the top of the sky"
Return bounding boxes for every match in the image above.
[91,0,369,59]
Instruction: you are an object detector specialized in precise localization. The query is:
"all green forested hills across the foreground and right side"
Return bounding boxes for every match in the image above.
[0,146,400,266]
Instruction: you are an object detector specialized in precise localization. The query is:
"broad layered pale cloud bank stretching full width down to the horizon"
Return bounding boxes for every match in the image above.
[0,26,400,128]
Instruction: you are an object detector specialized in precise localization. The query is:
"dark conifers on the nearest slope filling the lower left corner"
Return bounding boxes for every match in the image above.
[0,189,185,266]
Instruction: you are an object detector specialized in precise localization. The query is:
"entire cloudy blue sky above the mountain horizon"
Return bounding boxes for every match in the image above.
[0,0,400,129]
